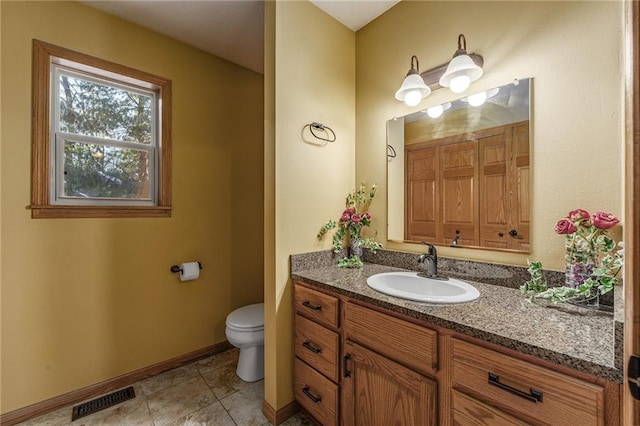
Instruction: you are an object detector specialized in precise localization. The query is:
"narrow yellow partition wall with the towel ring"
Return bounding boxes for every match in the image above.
[265,1,355,409]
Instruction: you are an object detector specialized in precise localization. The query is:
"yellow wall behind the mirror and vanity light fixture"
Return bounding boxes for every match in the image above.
[356,1,624,269]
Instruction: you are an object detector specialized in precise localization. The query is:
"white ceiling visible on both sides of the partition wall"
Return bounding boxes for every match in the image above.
[81,0,400,74]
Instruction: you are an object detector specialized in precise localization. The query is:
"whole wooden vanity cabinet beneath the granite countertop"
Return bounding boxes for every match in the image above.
[294,282,621,426]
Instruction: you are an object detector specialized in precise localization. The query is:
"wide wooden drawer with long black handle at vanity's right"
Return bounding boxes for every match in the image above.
[451,338,604,426]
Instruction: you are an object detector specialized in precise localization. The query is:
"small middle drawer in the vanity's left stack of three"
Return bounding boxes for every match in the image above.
[295,315,338,383]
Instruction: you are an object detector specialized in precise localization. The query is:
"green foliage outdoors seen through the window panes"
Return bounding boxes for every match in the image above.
[58,73,154,199]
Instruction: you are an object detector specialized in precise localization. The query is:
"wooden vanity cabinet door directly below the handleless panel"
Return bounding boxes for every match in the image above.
[341,341,437,426]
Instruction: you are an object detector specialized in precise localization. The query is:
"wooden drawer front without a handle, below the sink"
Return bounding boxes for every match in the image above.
[344,303,438,374]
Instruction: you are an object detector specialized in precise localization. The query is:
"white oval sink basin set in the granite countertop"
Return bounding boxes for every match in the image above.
[367,272,480,303]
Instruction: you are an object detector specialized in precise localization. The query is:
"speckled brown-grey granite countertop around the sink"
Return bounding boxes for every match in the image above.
[292,263,623,383]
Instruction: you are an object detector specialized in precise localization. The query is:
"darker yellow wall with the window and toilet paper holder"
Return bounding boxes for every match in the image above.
[0,1,263,412]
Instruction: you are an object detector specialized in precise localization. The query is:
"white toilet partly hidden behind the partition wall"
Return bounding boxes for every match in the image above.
[225,303,264,382]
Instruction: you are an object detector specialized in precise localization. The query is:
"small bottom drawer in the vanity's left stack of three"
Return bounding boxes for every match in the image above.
[294,358,338,426]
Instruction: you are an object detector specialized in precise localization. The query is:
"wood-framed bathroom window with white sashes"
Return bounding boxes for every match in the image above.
[31,40,171,218]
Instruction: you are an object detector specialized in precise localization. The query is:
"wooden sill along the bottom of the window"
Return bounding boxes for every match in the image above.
[28,205,171,219]
